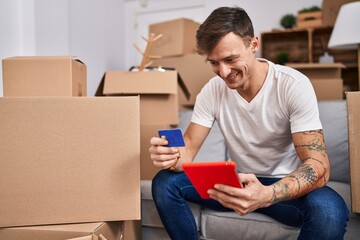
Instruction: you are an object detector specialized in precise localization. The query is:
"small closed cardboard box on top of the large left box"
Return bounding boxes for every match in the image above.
[2,57,86,97]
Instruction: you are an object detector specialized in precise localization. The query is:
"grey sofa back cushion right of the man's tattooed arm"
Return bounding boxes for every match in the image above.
[319,100,350,183]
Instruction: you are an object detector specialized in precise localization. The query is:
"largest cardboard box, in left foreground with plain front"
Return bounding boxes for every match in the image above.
[0,97,140,227]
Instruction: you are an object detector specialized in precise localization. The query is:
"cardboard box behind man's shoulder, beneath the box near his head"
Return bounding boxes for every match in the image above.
[153,54,215,107]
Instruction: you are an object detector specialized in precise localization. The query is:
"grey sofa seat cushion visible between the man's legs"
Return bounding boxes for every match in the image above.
[201,209,299,240]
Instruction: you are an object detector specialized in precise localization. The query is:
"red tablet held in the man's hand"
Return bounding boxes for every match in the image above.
[182,161,243,199]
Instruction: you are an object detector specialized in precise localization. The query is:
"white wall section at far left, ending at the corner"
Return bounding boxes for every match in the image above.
[0,0,125,96]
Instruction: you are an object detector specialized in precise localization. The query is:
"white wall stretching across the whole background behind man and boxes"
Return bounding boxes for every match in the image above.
[0,0,322,96]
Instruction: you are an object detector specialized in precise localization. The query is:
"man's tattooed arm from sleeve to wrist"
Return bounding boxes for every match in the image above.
[271,130,330,204]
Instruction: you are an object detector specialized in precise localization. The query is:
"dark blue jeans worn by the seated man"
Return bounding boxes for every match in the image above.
[152,170,348,240]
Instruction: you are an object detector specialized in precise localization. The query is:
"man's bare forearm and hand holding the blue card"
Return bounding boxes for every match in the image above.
[149,123,210,171]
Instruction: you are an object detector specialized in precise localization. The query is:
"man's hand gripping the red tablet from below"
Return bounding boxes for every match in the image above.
[208,173,273,216]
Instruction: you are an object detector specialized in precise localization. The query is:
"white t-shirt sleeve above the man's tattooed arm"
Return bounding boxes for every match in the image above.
[288,76,322,133]
